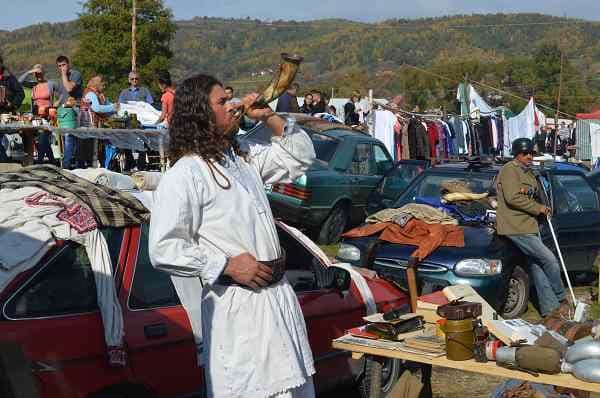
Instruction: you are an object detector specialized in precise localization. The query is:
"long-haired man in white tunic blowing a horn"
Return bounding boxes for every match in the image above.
[149,75,315,397]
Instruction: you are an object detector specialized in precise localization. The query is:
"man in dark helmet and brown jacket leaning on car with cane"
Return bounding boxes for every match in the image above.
[496,138,569,317]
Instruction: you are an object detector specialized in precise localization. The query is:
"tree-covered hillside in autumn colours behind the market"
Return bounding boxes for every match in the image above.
[0,14,600,114]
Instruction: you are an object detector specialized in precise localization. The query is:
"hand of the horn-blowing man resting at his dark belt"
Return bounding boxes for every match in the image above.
[223,253,273,290]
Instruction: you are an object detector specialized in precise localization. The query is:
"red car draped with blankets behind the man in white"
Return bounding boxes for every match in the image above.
[0,225,408,398]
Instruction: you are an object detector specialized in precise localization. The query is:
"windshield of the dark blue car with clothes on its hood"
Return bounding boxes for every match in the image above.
[394,173,494,208]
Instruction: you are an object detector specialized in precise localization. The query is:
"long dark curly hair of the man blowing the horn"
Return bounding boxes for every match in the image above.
[169,74,244,165]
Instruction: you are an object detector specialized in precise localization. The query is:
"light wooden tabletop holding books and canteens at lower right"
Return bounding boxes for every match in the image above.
[332,336,600,393]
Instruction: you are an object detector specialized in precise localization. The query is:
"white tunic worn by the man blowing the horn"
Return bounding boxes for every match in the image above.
[149,120,315,397]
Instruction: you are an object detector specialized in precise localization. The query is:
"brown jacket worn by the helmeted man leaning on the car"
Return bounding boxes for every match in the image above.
[496,160,544,235]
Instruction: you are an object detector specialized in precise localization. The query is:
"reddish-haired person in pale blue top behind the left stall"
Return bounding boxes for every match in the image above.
[78,75,119,169]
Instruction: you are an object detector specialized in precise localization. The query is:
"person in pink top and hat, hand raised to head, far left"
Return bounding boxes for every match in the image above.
[19,64,58,163]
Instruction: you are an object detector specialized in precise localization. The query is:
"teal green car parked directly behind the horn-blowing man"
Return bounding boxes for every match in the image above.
[240,114,393,244]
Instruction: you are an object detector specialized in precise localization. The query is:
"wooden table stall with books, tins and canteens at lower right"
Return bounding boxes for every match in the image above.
[332,285,600,397]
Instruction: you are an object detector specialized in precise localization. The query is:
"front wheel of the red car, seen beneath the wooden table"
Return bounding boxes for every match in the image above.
[358,357,403,398]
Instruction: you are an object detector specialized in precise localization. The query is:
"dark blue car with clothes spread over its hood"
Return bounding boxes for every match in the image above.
[338,162,600,318]
